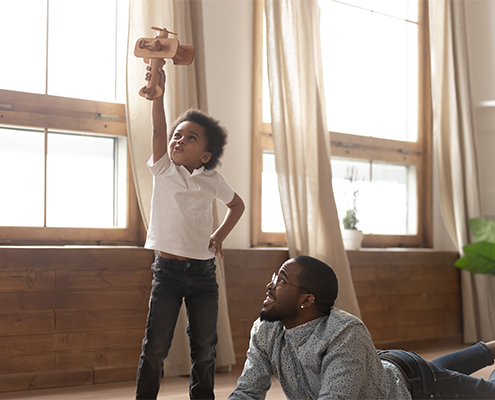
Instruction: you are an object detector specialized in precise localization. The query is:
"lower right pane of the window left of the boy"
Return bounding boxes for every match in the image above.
[46,133,117,228]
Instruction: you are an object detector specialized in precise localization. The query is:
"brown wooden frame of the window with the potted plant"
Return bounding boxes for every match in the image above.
[251,0,433,248]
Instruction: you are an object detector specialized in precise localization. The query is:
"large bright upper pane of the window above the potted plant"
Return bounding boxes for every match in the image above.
[320,1,418,141]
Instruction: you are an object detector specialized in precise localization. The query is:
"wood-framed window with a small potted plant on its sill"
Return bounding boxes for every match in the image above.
[252,0,431,247]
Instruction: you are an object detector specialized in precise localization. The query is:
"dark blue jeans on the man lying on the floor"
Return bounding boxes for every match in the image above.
[389,343,495,399]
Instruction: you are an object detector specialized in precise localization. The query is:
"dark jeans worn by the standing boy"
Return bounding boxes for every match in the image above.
[136,255,218,400]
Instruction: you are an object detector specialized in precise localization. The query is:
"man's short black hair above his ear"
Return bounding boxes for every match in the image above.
[294,256,339,314]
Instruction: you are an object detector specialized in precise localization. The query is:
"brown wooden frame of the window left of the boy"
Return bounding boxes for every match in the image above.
[0,89,144,245]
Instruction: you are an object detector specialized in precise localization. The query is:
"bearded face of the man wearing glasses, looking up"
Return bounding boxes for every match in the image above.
[260,260,301,329]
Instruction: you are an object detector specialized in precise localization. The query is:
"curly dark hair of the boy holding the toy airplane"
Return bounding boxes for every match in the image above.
[168,108,228,169]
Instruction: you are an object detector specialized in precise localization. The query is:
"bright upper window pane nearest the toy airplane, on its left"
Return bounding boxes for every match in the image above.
[48,0,127,102]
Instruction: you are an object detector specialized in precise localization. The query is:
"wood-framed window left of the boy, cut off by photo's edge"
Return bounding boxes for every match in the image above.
[0,0,141,244]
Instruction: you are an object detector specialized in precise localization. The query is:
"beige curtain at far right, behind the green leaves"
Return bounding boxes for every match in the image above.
[429,0,495,343]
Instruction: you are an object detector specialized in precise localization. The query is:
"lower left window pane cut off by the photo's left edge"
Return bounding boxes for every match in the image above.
[0,128,45,226]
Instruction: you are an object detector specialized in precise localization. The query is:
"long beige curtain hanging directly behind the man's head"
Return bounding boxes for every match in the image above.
[266,0,360,316]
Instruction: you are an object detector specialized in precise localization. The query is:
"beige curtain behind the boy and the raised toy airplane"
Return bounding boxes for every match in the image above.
[126,0,235,376]
